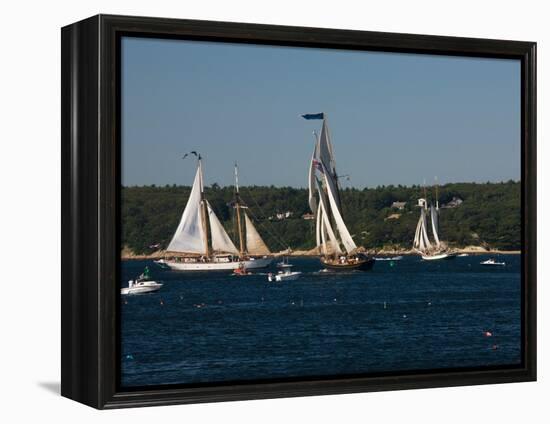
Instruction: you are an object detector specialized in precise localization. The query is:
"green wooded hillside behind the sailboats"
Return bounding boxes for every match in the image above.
[121,181,521,254]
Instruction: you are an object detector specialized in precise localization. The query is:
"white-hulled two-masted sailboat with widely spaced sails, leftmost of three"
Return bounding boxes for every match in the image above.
[157,154,272,271]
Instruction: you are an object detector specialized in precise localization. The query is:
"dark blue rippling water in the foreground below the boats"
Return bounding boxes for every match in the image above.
[121,255,521,387]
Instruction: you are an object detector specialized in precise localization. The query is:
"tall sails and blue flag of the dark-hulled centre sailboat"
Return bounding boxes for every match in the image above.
[304,114,357,255]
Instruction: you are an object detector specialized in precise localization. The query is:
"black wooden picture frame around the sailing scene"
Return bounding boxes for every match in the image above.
[61,15,537,409]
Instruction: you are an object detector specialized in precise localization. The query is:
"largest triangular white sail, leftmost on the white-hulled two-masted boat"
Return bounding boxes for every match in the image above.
[167,162,207,254]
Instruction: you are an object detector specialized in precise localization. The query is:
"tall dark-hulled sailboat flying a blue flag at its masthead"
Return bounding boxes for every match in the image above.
[302,113,375,270]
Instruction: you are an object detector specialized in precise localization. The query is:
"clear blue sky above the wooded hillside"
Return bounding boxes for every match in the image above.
[122,37,521,188]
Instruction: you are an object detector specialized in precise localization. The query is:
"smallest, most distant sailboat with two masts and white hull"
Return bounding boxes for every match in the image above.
[413,188,456,261]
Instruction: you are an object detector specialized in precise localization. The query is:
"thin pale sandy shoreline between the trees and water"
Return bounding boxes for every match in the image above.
[120,246,521,261]
